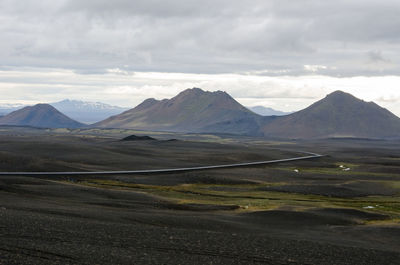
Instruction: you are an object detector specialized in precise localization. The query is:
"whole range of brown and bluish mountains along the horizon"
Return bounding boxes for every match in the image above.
[0,88,400,139]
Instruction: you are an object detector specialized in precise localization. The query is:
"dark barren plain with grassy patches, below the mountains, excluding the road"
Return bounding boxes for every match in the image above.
[0,127,400,264]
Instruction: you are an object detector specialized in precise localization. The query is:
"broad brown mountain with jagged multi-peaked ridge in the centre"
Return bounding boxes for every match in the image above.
[93,88,264,134]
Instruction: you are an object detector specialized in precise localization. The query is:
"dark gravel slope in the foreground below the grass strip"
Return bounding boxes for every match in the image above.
[0,174,400,265]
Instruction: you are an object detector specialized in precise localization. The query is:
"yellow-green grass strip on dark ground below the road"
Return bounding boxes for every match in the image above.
[81,180,400,220]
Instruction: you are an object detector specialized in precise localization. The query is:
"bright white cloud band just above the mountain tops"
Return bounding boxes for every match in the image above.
[0,69,400,116]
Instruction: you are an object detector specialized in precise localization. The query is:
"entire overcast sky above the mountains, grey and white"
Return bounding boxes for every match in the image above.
[0,0,400,115]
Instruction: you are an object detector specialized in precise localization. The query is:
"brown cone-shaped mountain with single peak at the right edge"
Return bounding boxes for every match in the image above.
[261,91,400,139]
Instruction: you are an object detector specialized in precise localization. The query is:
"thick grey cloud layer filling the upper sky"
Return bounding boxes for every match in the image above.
[0,0,400,76]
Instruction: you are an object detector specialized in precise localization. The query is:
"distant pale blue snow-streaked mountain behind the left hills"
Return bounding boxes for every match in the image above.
[50,99,127,124]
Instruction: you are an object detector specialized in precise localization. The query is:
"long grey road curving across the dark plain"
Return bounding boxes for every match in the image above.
[0,151,324,176]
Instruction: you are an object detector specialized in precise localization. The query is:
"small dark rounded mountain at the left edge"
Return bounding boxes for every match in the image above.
[0,104,84,128]
